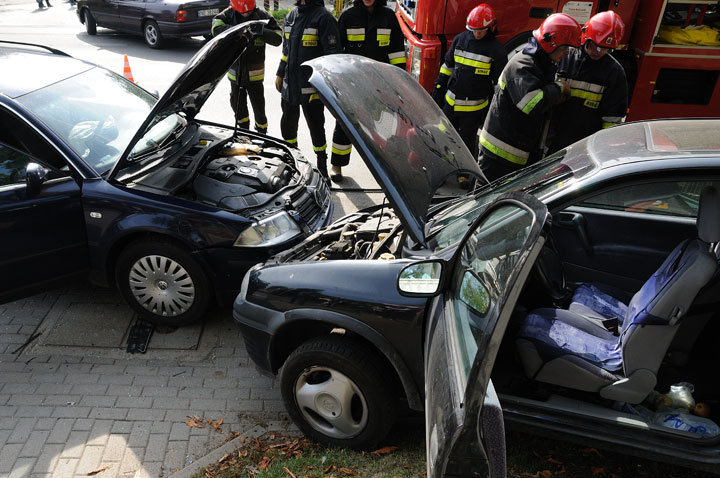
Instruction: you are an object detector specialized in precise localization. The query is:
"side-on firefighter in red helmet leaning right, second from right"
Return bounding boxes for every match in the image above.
[480,13,580,181]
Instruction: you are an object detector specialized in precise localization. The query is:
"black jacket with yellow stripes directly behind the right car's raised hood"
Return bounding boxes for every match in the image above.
[338,0,405,70]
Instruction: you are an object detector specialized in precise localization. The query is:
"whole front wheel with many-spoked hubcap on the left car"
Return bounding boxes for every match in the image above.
[115,240,211,326]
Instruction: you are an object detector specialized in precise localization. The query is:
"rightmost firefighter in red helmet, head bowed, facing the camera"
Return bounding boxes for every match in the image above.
[550,11,628,151]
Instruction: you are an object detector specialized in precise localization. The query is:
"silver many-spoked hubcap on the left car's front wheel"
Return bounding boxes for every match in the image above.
[128,256,195,316]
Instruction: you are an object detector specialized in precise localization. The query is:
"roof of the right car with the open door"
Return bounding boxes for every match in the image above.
[587,118,720,168]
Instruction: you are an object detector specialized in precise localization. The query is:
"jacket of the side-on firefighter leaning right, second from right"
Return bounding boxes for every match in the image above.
[480,37,563,166]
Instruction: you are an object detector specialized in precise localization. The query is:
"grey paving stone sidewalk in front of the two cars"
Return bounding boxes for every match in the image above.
[0,281,292,478]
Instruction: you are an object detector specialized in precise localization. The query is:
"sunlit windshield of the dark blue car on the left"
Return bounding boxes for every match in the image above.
[18,68,156,174]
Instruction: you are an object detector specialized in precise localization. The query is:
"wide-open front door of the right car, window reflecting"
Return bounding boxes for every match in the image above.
[425,193,547,477]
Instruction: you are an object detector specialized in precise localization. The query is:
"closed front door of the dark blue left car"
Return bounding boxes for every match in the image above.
[0,107,89,300]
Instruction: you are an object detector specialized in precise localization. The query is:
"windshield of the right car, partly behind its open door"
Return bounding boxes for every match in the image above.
[428,149,595,250]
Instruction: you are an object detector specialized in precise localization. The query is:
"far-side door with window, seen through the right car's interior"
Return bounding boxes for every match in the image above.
[553,174,720,295]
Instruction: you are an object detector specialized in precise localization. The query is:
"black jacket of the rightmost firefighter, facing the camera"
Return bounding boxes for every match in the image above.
[551,48,628,150]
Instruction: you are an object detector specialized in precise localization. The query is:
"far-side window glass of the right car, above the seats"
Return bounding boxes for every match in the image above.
[580,181,720,217]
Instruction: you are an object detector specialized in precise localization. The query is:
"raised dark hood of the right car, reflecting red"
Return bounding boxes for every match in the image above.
[303,55,484,245]
